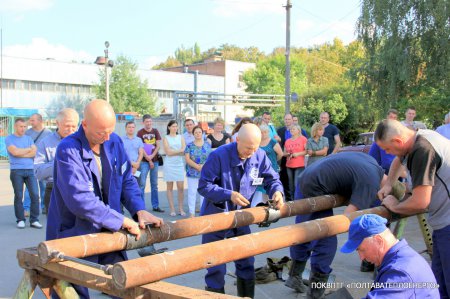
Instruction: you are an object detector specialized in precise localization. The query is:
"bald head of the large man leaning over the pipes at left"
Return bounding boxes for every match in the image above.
[81,99,116,148]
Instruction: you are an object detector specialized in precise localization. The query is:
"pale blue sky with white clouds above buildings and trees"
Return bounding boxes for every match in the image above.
[0,0,360,68]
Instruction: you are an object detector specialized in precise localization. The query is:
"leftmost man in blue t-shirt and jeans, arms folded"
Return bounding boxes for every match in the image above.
[5,118,42,229]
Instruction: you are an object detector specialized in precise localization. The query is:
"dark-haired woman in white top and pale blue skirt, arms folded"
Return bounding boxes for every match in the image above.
[163,120,186,216]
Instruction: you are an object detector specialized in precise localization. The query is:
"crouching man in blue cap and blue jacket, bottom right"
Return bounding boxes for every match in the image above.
[341,214,439,299]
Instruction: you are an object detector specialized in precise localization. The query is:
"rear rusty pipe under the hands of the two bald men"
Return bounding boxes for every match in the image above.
[38,195,346,264]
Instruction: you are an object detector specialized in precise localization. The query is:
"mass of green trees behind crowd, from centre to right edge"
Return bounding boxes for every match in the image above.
[150,0,450,137]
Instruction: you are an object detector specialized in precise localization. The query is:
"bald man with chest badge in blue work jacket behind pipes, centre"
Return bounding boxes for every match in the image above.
[198,124,284,298]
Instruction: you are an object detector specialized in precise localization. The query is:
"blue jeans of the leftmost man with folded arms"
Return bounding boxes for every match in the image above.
[9,169,39,223]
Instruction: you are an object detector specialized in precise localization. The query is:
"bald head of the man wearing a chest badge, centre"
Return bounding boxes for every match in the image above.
[236,124,261,159]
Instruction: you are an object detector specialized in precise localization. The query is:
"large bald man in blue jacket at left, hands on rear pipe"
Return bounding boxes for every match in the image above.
[46,100,163,298]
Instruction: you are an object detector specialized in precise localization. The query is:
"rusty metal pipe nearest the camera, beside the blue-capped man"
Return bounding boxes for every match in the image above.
[112,207,390,289]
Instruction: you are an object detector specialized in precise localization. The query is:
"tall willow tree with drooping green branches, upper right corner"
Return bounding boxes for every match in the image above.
[357,0,450,121]
